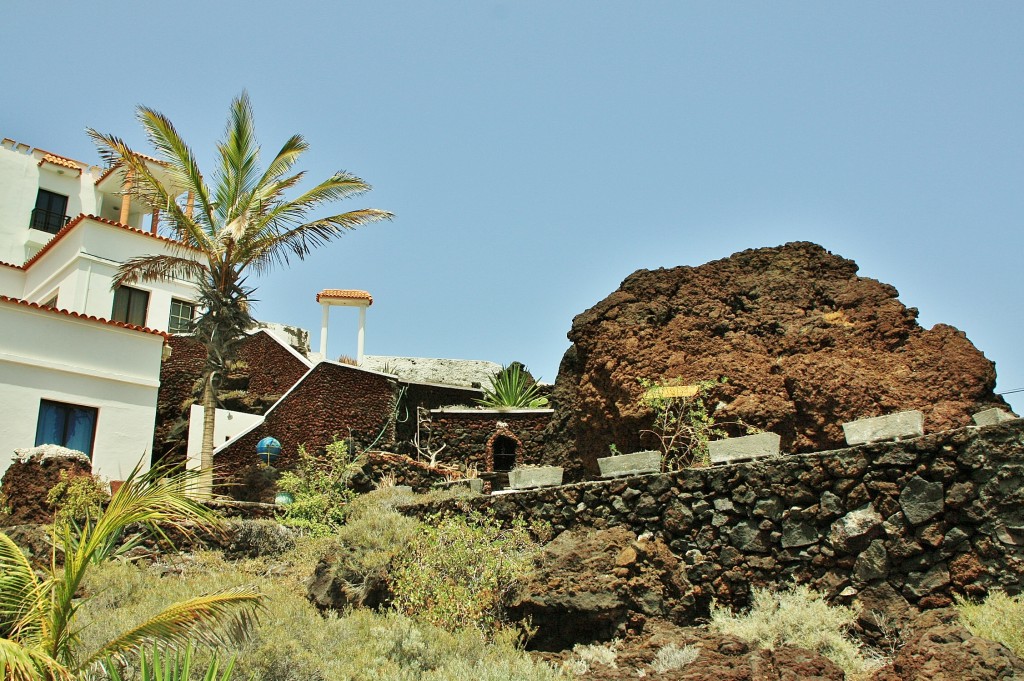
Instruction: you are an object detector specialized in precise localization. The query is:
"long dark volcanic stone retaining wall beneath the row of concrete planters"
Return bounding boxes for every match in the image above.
[403,420,1024,616]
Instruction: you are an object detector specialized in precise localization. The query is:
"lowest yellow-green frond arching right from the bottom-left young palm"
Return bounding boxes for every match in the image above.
[82,587,262,668]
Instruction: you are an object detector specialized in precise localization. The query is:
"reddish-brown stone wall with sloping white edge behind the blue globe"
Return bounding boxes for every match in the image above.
[214,361,397,494]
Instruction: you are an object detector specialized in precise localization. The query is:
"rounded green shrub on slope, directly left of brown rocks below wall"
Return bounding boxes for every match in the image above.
[390,513,540,636]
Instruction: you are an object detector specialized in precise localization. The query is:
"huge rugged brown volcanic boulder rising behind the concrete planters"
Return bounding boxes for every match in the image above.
[548,242,1006,472]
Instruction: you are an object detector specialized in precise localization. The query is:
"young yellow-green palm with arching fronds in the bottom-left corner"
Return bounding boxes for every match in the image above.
[0,467,261,681]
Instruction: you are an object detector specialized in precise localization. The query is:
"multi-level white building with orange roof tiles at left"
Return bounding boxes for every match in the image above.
[0,138,203,479]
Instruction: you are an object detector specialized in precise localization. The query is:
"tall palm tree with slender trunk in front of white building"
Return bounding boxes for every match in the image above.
[88,92,392,495]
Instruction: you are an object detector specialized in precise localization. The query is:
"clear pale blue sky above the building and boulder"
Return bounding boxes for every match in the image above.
[8,0,1024,411]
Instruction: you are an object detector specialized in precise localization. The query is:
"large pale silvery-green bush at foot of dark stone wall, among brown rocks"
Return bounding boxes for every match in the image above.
[711,585,881,677]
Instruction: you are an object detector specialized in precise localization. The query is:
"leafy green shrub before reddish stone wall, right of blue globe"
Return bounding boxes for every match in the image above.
[278,438,367,536]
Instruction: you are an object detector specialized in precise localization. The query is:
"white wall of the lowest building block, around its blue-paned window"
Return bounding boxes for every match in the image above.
[0,302,164,479]
